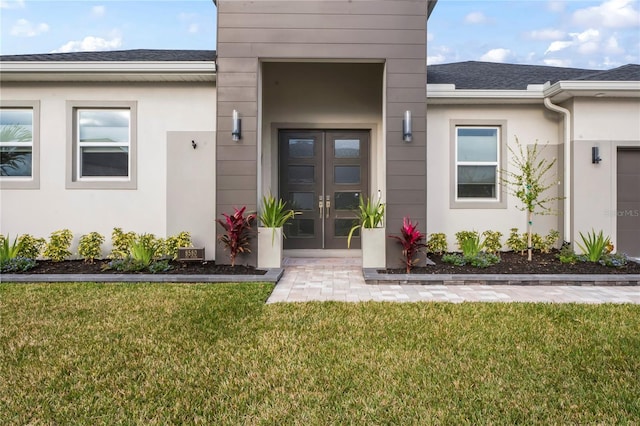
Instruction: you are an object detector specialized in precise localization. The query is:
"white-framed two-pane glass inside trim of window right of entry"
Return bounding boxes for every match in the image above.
[455,127,499,200]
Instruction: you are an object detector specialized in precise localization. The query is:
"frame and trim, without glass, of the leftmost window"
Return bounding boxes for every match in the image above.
[0,100,40,189]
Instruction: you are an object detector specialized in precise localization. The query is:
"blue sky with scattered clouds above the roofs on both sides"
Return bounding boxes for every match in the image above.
[0,0,640,69]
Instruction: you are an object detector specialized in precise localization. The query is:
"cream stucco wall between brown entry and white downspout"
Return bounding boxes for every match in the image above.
[428,103,562,250]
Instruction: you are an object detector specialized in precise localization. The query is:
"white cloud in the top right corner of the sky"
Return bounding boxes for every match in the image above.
[572,0,640,28]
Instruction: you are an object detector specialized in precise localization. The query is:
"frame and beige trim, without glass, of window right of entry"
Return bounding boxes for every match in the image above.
[450,120,507,209]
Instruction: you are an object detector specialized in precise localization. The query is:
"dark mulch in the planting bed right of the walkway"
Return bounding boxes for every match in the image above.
[380,252,640,274]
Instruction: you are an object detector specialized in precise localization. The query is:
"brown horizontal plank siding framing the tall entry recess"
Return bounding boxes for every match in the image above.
[216,0,433,264]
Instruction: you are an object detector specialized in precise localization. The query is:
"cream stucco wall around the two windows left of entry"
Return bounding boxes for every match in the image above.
[0,83,216,258]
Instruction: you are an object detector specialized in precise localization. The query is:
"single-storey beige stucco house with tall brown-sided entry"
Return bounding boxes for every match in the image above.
[0,0,640,266]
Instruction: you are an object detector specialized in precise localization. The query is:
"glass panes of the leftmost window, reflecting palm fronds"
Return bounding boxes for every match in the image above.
[0,108,33,177]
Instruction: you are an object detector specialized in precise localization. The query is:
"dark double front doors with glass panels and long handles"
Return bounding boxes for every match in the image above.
[278,130,370,249]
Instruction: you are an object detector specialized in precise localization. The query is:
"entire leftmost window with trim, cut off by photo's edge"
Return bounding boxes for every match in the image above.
[0,102,39,189]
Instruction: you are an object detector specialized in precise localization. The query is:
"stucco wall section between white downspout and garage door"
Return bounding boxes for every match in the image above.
[567,98,640,250]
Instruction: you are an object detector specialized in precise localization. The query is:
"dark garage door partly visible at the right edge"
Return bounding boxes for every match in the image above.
[616,148,640,257]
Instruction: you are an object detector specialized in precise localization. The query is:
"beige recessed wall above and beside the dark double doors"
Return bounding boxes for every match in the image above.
[260,62,386,200]
